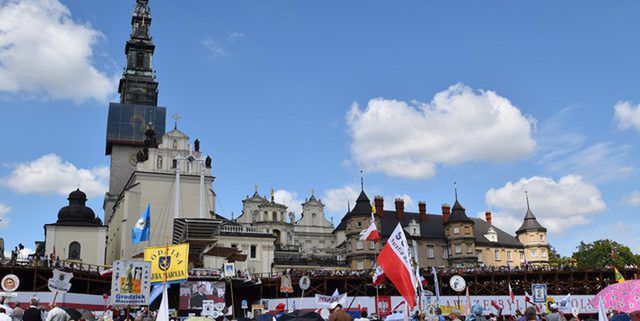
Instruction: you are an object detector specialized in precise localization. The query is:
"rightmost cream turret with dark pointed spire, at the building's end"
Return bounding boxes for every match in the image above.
[516,195,549,266]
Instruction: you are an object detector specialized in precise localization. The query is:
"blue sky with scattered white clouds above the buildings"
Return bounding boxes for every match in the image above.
[0,0,640,255]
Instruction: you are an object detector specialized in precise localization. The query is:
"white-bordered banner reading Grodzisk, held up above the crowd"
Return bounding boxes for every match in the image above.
[111,261,151,305]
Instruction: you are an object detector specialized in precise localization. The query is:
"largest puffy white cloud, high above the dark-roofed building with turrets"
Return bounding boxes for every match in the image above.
[347,84,536,178]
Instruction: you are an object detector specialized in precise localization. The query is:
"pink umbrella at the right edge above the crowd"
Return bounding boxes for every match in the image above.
[591,280,640,313]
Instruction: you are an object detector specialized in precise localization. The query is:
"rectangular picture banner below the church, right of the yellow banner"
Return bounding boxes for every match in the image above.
[179,281,225,310]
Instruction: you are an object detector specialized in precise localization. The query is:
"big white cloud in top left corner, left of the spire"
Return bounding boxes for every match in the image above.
[0,0,116,102]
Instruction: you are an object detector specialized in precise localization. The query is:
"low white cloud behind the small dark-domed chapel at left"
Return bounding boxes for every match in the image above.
[0,154,109,197]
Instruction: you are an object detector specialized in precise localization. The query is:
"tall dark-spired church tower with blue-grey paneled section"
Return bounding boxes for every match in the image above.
[103,0,166,222]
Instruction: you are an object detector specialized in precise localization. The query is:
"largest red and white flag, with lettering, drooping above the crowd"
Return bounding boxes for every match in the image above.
[377,223,417,309]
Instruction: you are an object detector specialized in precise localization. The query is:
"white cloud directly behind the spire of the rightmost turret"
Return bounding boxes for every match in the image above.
[485,175,606,234]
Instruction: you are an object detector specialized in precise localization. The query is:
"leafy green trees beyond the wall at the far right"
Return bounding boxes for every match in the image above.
[572,239,638,269]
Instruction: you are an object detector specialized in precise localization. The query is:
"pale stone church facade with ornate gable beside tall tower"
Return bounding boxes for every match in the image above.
[106,125,215,264]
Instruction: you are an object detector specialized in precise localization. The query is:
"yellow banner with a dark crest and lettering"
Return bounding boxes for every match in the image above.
[144,244,189,283]
